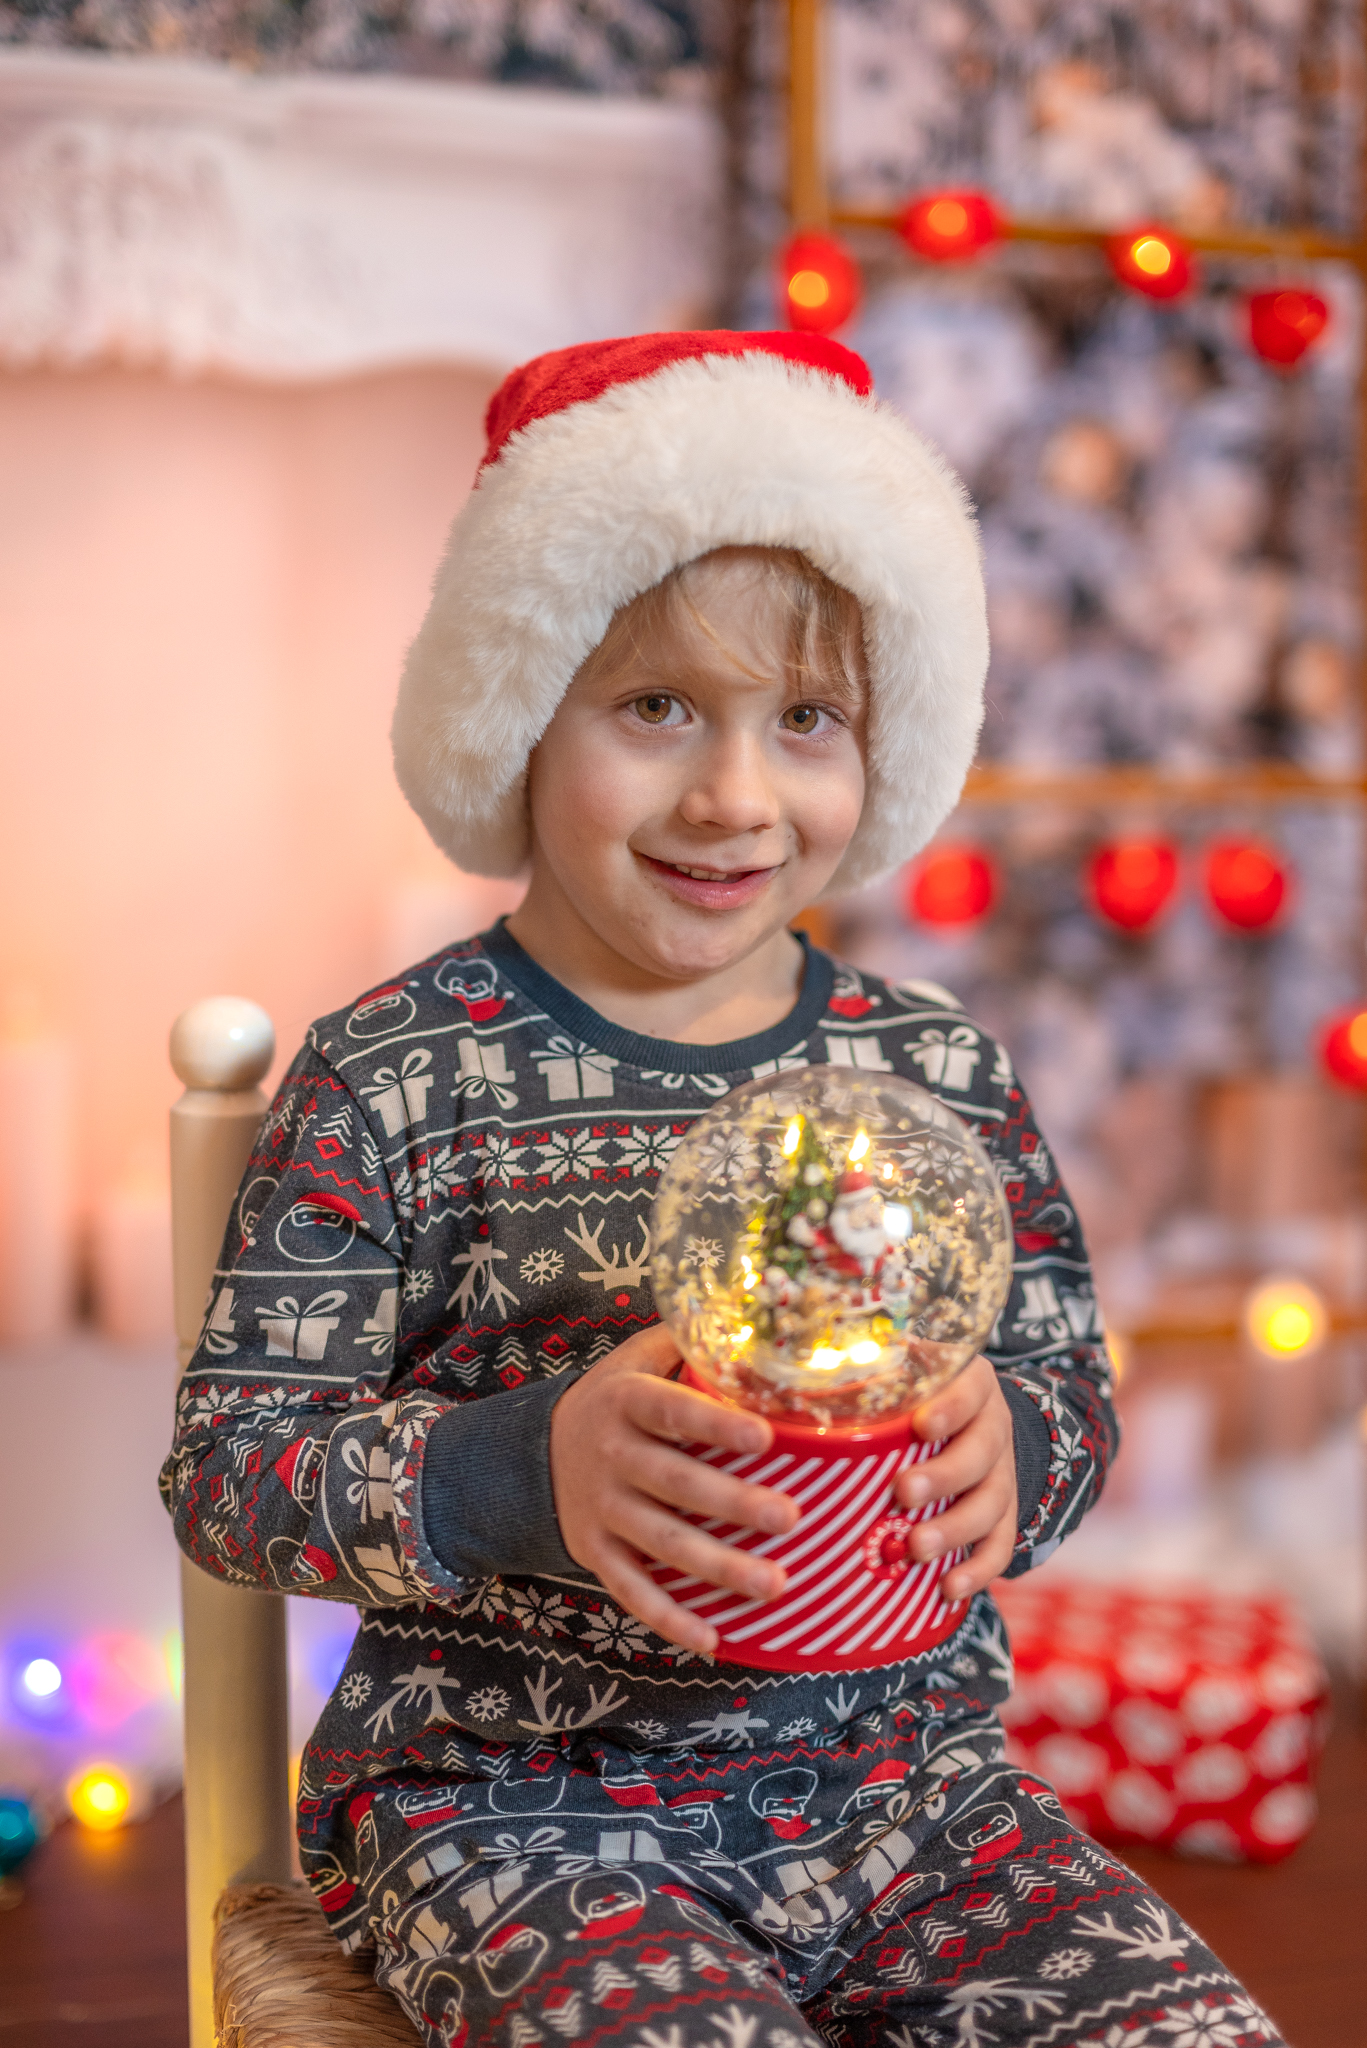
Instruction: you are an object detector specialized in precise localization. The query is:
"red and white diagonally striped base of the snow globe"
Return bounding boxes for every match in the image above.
[650,1374,967,1671]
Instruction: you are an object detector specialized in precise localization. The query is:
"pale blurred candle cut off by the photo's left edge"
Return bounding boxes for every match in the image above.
[0,1034,74,1343]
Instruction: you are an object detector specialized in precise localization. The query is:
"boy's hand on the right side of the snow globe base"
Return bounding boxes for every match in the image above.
[896,1358,1017,1599]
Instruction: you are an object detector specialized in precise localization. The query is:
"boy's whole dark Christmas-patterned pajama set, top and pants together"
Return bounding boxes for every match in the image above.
[162,926,1275,2048]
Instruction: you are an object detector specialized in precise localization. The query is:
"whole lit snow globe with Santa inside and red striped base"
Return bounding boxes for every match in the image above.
[652,1067,1012,1669]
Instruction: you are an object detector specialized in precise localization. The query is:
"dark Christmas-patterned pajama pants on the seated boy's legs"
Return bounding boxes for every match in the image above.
[340,1710,1281,2048]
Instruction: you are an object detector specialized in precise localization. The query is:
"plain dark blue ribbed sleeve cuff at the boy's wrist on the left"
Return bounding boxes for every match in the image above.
[422,1372,578,1579]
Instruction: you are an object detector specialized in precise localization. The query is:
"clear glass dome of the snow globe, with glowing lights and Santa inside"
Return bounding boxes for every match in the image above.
[652,1067,1012,1430]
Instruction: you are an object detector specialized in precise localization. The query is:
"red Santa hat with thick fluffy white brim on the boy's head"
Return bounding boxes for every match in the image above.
[393,332,988,889]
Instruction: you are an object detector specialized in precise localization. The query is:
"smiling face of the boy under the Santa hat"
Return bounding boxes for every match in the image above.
[529,549,865,981]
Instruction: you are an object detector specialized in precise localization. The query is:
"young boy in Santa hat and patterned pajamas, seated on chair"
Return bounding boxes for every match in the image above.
[164,334,1275,2048]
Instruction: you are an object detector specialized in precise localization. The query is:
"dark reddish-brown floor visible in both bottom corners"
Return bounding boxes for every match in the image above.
[0,1698,1367,2048]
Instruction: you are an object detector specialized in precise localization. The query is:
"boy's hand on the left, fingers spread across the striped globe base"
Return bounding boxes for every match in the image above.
[551,1323,795,1653]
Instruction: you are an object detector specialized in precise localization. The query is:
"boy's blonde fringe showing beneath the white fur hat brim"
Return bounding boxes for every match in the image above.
[578,547,867,707]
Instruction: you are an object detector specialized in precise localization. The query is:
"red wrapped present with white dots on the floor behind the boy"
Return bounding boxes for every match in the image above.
[994,1575,1328,1864]
